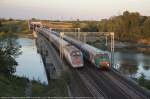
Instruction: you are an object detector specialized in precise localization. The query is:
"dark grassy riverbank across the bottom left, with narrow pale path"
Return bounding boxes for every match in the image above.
[0,72,68,97]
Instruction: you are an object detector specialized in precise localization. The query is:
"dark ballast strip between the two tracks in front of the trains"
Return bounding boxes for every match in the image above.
[84,67,131,99]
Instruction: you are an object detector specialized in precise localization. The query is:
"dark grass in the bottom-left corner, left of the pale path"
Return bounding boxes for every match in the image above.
[0,75,27,97]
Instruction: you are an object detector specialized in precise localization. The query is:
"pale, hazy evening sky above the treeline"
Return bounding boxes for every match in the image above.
[0,0,150,20]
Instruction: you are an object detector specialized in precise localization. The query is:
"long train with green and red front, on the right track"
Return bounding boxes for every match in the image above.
[49,30,111,69]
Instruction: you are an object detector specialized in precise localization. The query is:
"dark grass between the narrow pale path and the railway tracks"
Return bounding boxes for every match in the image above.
[32,72,69,97]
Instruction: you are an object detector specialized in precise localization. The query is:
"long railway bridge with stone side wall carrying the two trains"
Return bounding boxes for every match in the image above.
[30,21,150,99]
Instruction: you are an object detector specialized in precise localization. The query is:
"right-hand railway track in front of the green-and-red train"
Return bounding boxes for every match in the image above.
[87,63,149,99]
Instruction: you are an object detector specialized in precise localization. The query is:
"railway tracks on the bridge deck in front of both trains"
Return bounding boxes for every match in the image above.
[38,33,150,99]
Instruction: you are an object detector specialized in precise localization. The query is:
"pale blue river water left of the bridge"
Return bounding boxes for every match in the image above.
[15,38,47,83]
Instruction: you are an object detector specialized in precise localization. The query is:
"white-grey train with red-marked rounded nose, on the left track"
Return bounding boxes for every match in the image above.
[37,28,84,68]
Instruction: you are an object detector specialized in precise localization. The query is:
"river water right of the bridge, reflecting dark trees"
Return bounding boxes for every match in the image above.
[115,52,150,79]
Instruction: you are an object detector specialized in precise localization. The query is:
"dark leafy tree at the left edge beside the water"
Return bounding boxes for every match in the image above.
[0,39,21,75]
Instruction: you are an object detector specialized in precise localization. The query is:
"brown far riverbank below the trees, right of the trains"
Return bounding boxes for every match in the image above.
[87,40,150,54]
